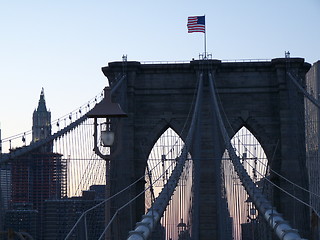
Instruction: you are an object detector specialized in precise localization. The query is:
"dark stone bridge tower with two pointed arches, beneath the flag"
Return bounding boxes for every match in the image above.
[102,58,310,240]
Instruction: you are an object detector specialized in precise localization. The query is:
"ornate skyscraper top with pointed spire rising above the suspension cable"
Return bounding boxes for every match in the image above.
[32,88,51,142]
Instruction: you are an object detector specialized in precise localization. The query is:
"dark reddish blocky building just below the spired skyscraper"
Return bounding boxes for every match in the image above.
[11,152,66,206]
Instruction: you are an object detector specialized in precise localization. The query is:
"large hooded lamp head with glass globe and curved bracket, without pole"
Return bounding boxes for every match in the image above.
[87,87,127,159]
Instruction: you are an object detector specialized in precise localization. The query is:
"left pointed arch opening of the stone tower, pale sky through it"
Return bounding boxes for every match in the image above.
[145,127,194,239]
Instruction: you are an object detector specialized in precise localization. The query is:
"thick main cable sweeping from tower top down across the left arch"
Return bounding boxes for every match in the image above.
[128,73,203,240]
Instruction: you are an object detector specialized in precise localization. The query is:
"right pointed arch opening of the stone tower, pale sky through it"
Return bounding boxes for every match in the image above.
[221,126,271,239]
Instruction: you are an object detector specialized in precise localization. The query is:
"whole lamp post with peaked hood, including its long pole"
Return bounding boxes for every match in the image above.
[87,87,127,240]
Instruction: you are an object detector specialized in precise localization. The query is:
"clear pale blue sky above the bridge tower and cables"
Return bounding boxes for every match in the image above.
[0,0,320,137]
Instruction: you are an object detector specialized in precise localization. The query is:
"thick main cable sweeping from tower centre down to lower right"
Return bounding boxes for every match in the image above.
[209,73,302,240]
